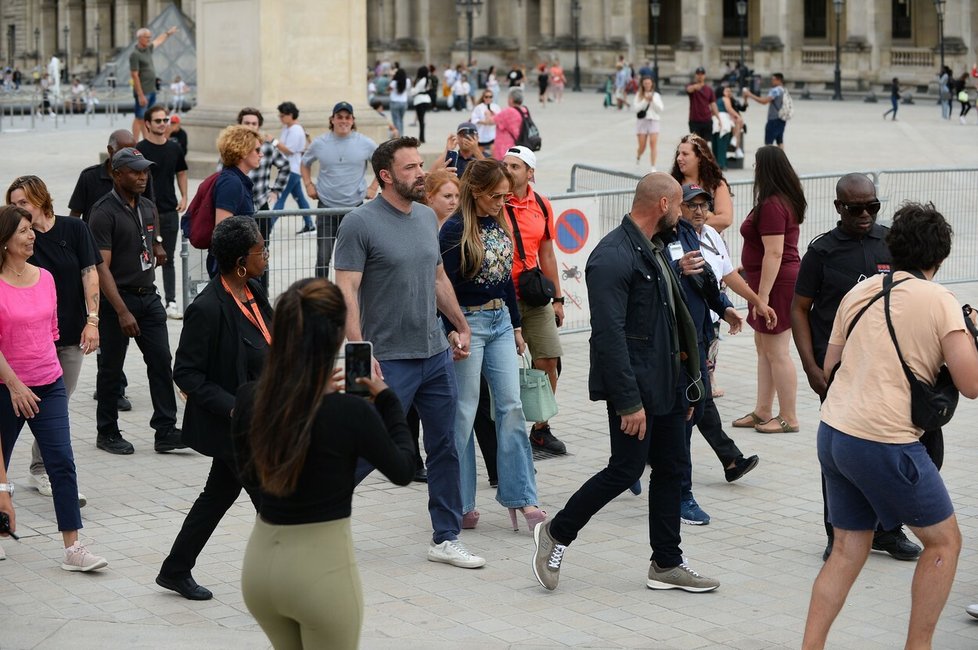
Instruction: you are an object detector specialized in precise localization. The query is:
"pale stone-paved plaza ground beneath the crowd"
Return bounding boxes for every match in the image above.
[0,92,978,650]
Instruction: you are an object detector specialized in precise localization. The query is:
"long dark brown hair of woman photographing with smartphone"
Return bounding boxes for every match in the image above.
[250,278,346,496]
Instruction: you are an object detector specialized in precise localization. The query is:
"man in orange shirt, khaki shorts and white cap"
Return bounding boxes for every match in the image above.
[503,147,567,454]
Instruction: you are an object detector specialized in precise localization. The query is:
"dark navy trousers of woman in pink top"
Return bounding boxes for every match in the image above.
[0,374,81,531]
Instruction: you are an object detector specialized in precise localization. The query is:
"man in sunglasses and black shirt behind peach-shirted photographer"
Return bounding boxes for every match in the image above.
[791,174,924,560]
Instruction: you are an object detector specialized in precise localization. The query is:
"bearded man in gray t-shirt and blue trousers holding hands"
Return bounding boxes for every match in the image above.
[336,138,486,569]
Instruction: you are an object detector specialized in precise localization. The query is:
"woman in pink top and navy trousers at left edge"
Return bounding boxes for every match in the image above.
[0,205,108,571]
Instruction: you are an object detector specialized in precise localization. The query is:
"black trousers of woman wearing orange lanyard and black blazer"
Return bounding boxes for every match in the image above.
[160,458,259,580]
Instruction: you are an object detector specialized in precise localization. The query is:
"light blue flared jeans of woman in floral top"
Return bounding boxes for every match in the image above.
[455,307,538,512]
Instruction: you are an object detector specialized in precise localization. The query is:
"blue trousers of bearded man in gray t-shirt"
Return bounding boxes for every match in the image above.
[355,350,462,544]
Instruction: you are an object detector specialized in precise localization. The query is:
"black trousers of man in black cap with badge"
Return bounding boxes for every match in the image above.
[95,290,177,436]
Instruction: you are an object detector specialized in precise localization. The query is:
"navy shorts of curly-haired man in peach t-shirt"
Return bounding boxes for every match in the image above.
[818,422,954,530]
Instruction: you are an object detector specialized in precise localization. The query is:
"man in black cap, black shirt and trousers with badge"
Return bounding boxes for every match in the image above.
[89,148,185,454]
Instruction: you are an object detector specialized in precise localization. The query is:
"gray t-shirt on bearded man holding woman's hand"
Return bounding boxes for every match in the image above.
[333,188,448,361]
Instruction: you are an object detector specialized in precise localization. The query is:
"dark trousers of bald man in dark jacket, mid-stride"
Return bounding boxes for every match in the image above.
[550,389,689,568]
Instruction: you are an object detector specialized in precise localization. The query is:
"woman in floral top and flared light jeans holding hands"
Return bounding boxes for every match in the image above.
[439,160,547,531]
